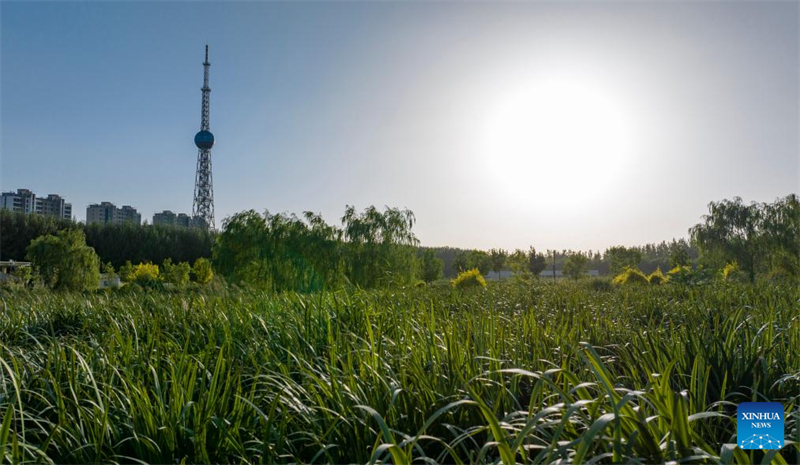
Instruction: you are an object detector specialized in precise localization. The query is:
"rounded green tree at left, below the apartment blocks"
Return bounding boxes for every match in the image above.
[26,229,100,291]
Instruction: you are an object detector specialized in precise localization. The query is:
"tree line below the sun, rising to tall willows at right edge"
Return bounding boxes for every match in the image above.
[433,194,800,282]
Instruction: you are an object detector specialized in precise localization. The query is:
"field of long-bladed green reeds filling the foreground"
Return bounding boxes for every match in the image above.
[0,282,800,463]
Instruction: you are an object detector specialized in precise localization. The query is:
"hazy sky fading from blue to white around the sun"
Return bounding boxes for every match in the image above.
[0,1,800,250]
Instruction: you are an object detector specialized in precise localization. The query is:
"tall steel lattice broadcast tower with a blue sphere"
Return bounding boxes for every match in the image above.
[192,45,214,229]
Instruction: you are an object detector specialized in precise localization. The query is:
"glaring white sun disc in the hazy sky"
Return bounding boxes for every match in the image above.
[483,79,633,207]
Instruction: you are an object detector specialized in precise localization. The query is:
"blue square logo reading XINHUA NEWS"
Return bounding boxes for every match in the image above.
[736,402,785,450]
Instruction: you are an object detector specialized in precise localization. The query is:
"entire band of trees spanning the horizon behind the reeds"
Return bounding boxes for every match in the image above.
[0,194,800,292]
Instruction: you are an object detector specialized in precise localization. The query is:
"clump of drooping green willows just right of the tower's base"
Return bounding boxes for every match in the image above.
[213,207,419,292]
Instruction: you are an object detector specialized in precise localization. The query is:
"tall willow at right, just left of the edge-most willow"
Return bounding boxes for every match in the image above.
[689,197,765,282]
